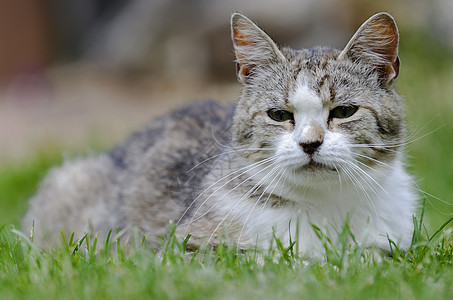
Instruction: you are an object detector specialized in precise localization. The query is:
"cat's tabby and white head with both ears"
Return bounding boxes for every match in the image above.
[231,13,405,189]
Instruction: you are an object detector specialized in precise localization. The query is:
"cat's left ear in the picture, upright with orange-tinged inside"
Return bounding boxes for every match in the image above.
[231,13,285,83]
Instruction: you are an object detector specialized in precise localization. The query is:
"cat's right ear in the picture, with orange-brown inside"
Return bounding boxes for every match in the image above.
[339,13,400,84]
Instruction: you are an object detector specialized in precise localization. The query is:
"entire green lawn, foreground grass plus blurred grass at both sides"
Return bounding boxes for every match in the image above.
[0,34,453,299]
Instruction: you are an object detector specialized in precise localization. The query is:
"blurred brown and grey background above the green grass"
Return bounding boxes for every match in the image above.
[0,0,453,163]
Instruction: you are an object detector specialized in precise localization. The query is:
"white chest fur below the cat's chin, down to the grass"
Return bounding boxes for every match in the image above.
[221,157,416,256]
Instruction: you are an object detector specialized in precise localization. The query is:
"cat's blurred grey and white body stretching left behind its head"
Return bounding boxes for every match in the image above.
[23,101,233,243]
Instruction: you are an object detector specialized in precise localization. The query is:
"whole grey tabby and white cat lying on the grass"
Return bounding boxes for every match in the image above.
[23,13,418,256]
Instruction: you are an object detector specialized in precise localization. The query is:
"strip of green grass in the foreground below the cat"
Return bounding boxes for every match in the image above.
[0,217,453,299]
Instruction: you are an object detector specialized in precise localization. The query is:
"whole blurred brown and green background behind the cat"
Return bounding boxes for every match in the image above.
[0,0,453,230]
